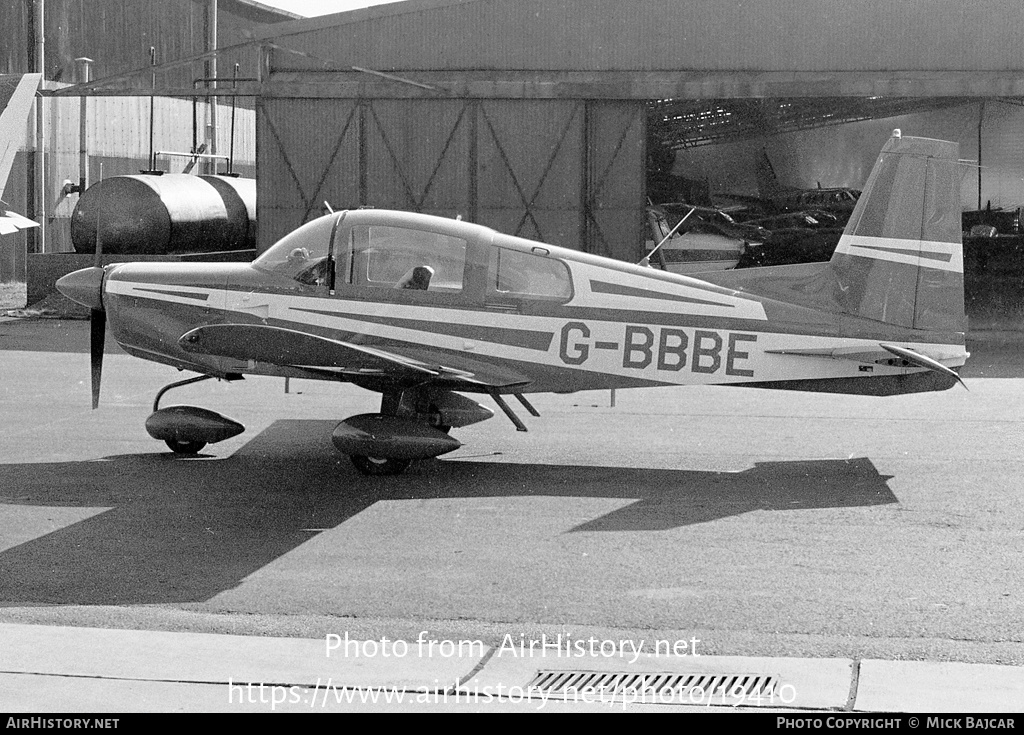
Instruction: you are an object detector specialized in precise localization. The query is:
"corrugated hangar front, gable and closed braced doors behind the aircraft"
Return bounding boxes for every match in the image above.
[247,0,1024,260]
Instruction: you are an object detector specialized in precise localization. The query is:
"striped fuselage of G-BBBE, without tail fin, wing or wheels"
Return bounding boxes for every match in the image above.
[97,204,965,399]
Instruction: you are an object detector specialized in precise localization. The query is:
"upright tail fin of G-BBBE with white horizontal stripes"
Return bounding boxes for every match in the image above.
[827,130,967,333]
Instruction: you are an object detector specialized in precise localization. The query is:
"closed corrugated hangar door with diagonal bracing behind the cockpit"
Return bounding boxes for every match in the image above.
[256,97,646,261]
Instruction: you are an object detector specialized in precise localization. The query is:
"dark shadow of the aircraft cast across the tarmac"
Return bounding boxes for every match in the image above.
[0,421,897,606]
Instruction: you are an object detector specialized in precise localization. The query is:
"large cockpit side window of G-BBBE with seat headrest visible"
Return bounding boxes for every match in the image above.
[336,224,467,294]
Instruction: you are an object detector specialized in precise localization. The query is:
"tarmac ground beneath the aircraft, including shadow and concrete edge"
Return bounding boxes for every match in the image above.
[0,320,1024,714]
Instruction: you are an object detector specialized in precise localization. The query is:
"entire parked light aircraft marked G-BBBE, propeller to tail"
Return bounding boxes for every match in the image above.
[57,131,968,474]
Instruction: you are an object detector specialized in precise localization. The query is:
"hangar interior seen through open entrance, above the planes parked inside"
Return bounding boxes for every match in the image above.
[648,96,1024,211]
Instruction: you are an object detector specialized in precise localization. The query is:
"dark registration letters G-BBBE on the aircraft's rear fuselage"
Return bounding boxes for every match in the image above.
[558,321,758,378]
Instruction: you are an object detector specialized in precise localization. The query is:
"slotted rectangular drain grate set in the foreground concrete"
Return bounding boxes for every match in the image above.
[528,669,779,705]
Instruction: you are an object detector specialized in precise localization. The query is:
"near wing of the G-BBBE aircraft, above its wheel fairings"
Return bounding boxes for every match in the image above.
[178,325,530,392]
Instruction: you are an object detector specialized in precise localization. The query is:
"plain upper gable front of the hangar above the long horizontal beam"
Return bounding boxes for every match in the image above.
[263,0,1024,89]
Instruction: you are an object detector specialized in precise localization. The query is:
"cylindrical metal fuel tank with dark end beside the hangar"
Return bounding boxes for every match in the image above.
[71,174,256,255]
